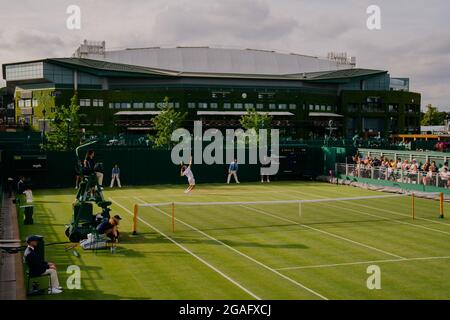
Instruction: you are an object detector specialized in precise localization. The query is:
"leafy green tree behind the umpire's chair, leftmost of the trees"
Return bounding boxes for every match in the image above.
[44,94,81,151]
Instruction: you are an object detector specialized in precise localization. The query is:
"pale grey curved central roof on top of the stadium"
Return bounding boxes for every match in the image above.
[79,47,354,76]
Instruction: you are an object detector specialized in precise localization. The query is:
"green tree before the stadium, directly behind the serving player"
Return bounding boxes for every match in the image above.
[149,97,186,148]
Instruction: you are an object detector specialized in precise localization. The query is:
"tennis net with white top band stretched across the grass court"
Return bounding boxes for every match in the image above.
[132,194,445,233]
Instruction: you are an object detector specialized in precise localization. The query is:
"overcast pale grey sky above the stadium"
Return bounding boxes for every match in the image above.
[0,0,450,110]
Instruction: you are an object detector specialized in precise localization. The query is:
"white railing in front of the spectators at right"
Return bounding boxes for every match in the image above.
[336,163,450,188]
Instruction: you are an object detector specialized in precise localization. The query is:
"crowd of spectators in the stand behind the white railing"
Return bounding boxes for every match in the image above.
[351,155,450,187]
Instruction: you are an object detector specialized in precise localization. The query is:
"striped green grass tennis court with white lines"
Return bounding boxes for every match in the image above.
[21,182,450,299]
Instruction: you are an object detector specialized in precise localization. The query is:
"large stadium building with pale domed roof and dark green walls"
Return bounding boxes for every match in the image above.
[2,41,421,138]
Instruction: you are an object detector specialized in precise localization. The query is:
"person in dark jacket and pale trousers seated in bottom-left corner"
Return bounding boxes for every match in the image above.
[23,236,62,294]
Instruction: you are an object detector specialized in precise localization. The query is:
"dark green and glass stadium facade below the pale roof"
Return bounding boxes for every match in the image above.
[3,59,421,139]
